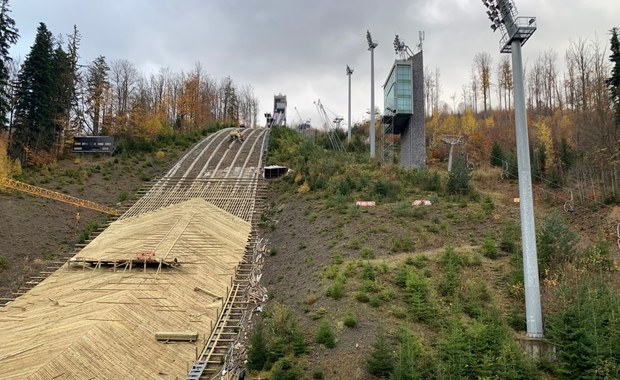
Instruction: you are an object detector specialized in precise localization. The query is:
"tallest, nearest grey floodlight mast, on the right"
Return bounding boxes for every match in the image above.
[482,0,543,338]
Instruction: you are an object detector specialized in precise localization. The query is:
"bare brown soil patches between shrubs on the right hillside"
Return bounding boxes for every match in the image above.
[254,169,620,379]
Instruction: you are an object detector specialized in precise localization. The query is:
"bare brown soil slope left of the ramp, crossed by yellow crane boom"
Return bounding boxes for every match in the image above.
[0,150,180,298]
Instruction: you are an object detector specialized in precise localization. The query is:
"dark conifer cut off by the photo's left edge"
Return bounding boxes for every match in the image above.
[0,0,19,130]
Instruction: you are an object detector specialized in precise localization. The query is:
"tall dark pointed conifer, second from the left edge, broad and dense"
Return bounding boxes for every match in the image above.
[12,23,56,156]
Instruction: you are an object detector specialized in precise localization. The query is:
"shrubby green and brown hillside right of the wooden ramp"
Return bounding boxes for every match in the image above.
[249,128,620,379]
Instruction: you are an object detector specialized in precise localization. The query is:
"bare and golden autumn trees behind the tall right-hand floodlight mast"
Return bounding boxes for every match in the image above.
[424,28,620,171]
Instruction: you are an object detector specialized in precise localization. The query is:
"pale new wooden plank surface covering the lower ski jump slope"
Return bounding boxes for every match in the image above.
[0,199,250,380]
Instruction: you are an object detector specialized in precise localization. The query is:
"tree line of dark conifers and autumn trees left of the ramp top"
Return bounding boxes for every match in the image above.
[0,0,259,165]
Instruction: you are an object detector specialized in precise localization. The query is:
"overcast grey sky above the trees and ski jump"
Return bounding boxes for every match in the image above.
[9,0,620,126]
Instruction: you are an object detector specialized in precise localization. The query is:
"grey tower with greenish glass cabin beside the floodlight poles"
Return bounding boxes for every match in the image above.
[382,32,426,169]
